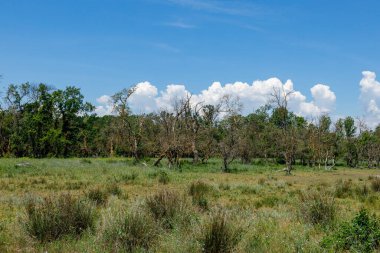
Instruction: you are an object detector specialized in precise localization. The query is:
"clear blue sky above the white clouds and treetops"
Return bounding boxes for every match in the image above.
[0,0,380,122]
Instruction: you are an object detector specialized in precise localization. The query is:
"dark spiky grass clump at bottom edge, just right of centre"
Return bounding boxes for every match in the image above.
[201,211,241,253]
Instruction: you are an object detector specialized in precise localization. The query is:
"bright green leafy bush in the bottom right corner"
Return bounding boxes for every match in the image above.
[321,210,380,252]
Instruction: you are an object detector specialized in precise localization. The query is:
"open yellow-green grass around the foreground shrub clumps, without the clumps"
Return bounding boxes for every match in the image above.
[0,158,380,252]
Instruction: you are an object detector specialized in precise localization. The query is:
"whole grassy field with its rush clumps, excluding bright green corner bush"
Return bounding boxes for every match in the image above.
[0,158,380,252]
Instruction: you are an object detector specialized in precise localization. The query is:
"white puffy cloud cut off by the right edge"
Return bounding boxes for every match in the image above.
[360,71,380,127]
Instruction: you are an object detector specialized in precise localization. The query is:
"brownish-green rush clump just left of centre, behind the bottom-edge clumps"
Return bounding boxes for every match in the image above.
[146,190,187,229]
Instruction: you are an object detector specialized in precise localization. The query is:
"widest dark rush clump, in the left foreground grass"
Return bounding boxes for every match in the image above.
[24,194,96,242]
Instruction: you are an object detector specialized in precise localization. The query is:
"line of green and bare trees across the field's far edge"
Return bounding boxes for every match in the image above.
[0,83,380,173]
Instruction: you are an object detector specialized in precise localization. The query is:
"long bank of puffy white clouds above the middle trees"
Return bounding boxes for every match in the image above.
[97,78,336,117]
